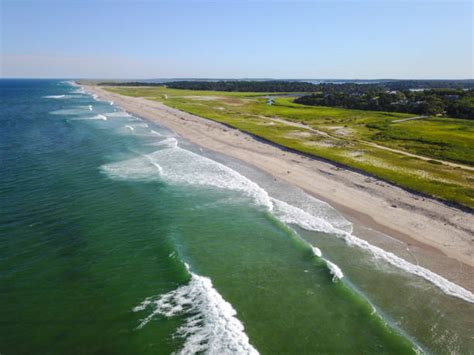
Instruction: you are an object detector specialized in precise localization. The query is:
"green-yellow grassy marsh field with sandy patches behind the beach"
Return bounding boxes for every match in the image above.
[104,87,474,207]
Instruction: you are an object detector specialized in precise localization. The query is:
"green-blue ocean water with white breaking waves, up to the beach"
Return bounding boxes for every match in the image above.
[0,80,474,354]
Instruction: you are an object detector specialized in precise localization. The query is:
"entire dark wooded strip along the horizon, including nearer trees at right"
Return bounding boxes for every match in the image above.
[99,79,474,119]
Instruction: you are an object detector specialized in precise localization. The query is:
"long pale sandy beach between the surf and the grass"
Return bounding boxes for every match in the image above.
[81,85,474,292]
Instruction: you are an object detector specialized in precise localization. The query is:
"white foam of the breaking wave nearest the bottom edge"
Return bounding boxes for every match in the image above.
[133,266,258,354]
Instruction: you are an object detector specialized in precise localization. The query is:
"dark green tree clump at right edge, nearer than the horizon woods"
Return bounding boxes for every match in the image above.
[295,88,474,119]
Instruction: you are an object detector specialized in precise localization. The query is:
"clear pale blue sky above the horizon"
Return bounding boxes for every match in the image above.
[0,0,474,79]
